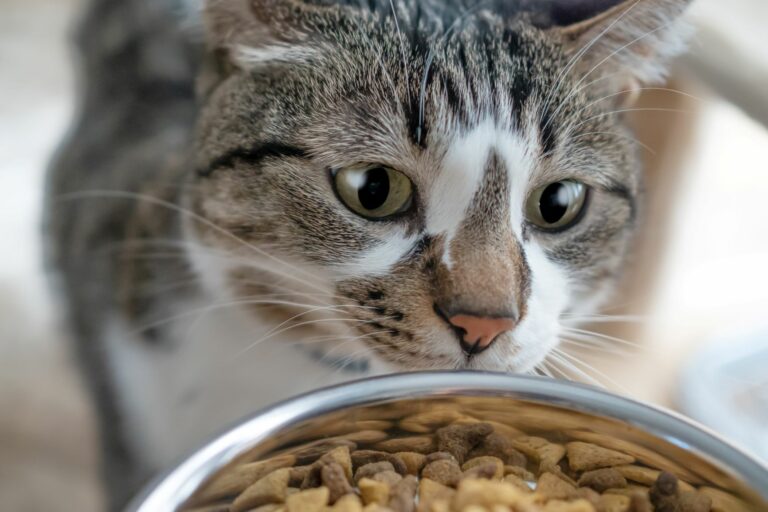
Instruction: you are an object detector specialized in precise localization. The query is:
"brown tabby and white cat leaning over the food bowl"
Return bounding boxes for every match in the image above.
[45,0,689,508]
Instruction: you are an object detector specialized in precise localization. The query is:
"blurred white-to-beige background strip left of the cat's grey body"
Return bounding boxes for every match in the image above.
[0,0,100,512]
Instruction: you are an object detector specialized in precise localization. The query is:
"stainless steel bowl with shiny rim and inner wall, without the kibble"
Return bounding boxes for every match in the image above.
[128,372,768,512]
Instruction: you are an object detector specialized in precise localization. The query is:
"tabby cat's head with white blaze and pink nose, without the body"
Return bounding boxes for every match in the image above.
[184,0,688,371]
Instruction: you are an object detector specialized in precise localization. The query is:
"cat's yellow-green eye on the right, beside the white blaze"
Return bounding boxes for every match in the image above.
[526,180,589,231]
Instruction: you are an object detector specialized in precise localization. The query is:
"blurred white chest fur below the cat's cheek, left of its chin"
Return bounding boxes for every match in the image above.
[104,299,384,471]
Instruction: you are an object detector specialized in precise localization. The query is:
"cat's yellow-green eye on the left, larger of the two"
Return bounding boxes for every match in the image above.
[332,165,413,220]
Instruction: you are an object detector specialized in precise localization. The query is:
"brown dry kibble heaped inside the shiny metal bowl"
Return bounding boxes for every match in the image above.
[185,412,749,512]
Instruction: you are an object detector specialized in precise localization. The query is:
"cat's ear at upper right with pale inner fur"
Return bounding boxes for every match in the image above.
[550,0,691,91]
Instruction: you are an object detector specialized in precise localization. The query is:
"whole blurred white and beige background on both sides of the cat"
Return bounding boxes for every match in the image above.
[0,0,768,512]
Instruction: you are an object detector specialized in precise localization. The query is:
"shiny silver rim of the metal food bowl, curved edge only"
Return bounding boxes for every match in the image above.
[126,371,768,512]
